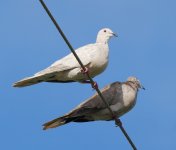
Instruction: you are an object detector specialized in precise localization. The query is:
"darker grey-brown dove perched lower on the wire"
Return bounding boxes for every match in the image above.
[43,76,145,130]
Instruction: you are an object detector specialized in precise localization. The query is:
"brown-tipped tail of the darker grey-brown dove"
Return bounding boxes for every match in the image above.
[43,115,75,130]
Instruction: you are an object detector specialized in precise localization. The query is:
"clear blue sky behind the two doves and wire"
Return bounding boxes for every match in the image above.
[0,0,176,150]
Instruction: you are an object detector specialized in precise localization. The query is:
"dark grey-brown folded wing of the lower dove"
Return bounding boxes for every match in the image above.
[69,82,122,117]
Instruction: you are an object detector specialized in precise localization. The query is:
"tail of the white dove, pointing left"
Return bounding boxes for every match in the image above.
[13,76,44,87]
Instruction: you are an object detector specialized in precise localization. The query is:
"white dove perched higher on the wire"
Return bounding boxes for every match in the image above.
[13,28,117,87]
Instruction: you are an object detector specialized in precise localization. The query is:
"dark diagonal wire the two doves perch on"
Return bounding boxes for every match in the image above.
[39,0,137,150]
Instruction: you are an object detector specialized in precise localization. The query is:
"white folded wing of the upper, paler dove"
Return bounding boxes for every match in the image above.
[35,44,97,76]
